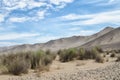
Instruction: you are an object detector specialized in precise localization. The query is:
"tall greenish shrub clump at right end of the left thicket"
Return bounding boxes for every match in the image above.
[31,50,56,69]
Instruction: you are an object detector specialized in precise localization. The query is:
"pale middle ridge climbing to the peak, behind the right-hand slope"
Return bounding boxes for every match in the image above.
[42,27,114,50]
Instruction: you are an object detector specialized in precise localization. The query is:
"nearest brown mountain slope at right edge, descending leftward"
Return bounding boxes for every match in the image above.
[82,27,120,49]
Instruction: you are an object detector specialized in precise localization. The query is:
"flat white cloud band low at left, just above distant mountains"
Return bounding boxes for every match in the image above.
[0,33,40,40]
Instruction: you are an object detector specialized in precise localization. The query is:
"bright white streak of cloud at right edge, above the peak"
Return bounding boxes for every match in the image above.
[80,11,120,25]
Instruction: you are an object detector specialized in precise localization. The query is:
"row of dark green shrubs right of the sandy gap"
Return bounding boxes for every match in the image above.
[58,47,102,62]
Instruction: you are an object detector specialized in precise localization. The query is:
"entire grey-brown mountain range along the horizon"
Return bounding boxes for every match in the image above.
[0,27,120,53]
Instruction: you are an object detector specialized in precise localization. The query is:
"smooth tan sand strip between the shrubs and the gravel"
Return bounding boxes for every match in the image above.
[0,57,115,80]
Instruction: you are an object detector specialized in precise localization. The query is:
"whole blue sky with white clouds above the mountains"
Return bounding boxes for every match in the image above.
[0,0,120,46]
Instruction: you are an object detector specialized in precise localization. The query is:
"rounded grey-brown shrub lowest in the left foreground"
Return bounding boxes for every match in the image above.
[7,59,29,75]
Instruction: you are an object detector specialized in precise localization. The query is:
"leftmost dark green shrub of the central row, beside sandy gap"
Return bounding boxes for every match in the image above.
[60,48,77,62]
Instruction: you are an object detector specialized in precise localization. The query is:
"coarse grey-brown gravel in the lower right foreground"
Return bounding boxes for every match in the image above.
[9,62,120,80]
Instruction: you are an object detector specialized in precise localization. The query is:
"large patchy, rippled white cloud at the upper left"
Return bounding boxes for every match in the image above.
[0,0,73,22]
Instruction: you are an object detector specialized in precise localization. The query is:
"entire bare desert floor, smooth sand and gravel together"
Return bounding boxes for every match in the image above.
[0,59,120,80]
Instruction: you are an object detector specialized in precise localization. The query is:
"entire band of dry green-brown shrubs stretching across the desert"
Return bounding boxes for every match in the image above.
[0,47,120,75]
